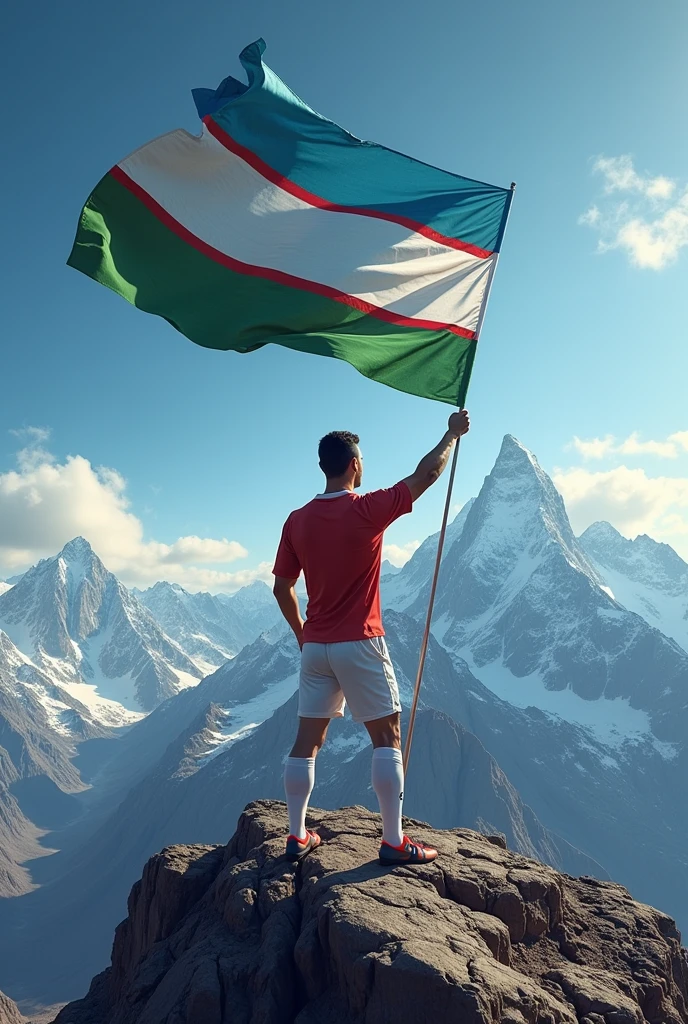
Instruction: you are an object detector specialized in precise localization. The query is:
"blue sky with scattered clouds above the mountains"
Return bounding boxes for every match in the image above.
[0,0,688,591]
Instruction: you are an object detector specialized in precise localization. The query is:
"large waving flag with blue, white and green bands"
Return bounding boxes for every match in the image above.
[68,40,512,404]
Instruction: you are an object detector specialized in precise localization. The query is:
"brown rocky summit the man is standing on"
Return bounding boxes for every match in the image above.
[55,802,688,1024]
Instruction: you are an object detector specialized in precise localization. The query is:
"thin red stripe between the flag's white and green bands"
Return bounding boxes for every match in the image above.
[110,165,475,341]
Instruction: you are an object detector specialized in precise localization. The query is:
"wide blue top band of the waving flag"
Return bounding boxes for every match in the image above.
[194,39,510,250]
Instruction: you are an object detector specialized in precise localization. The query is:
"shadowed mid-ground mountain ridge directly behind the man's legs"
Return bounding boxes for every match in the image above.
[0,614,605,1001]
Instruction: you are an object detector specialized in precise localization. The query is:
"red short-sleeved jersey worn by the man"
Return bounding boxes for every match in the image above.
[272,482,413,643]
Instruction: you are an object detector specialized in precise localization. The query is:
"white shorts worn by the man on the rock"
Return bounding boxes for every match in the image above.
[299,637,401,722]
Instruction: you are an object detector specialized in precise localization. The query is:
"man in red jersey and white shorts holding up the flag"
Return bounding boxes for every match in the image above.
[272,410,469,864]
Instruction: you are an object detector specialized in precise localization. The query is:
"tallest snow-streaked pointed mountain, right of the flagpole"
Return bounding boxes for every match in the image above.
[383,436,688,933]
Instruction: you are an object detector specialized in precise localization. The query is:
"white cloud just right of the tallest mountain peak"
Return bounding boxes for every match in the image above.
[552,466,688,557]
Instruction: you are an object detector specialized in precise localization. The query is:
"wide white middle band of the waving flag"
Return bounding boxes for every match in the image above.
[120,125,496,331]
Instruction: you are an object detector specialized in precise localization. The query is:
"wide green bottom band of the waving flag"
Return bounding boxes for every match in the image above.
[68,175,476,406]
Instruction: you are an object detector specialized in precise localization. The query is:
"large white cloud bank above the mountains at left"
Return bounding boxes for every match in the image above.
[0,440,270,591]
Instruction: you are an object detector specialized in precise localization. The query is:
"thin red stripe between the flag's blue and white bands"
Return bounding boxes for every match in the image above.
[203,115,492,259]
